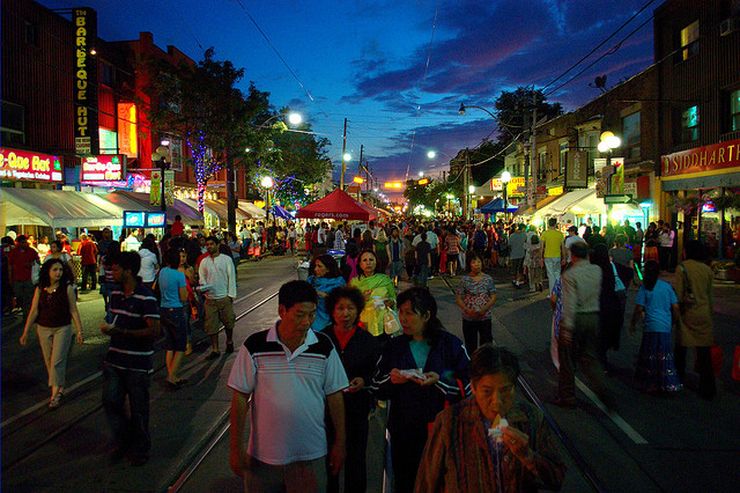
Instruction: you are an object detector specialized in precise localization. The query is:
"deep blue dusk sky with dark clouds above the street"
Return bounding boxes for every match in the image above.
[41,0,661,192]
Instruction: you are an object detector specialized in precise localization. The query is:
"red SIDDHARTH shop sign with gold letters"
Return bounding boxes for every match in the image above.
[660,139,740,177]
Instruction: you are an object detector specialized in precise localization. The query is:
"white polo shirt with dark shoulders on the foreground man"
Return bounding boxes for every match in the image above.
[228,322,349,465]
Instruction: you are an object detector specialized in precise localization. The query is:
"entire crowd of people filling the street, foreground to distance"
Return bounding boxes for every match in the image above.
[3,210,716,492]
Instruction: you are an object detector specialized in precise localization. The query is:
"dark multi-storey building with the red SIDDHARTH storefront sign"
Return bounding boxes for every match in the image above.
[654,0,740,257]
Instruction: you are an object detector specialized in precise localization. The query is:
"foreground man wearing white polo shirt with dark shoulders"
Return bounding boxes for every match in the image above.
[228,281,349,493]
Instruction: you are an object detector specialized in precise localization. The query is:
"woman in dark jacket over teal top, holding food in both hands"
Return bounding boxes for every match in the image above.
[373,288,470,493]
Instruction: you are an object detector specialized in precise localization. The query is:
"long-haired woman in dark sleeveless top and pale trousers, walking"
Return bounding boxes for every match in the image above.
[20,259,82,409]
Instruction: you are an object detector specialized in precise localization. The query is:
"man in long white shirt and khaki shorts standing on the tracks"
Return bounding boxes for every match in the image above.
[198,236,236,359]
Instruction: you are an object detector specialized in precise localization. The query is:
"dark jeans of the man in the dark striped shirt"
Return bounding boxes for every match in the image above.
[103,365,152,456]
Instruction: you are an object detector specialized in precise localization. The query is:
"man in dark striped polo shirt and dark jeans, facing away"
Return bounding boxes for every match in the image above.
[100,252,159,466]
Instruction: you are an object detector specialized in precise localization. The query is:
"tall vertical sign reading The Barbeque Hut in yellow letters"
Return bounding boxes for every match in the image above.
[72,8,98,156]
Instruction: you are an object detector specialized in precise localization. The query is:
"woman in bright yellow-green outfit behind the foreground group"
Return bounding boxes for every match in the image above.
[350,250,396,337]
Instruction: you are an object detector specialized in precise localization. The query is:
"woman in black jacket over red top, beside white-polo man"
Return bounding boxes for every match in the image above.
[323,287,380,493]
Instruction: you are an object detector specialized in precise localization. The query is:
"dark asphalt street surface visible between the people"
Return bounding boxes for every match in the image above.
[3,257,740,492]
